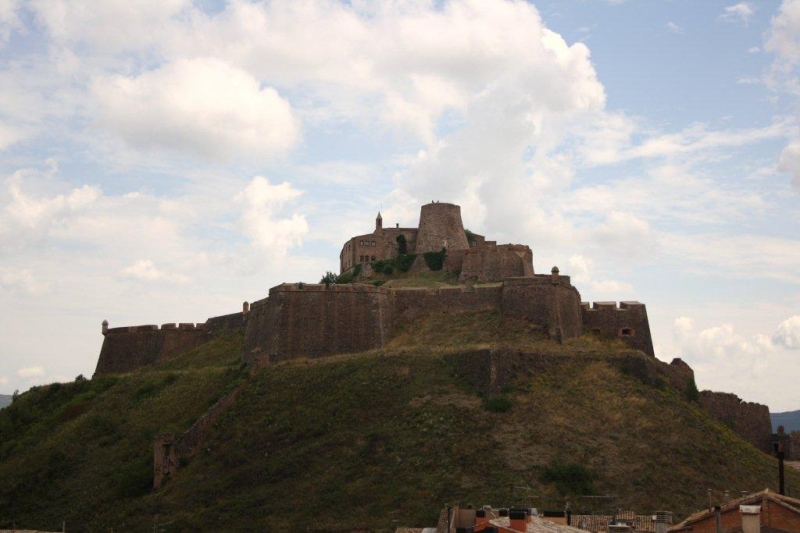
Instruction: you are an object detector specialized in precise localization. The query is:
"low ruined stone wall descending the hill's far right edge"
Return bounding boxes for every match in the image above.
[700,390,772,453]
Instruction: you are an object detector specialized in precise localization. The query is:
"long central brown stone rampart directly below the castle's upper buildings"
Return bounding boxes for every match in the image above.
[243,271,653,364]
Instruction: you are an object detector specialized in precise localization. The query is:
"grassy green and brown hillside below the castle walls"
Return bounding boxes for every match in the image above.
[0,313,800,531]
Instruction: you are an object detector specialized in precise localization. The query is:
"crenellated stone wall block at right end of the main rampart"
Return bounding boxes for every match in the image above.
[581,302,655,357]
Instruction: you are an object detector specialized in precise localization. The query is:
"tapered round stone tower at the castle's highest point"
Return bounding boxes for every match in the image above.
[414,202,469,254]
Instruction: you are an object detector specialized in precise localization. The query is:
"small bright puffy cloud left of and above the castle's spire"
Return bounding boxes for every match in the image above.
[236,176,308,257]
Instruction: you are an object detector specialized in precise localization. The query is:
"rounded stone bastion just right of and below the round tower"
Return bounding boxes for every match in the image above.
[459,244,533,283]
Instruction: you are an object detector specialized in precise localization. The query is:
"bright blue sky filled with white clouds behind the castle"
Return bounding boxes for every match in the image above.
[0,0,800,412]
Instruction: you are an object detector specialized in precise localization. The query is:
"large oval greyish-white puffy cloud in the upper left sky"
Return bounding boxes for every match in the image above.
[93,58,300,159]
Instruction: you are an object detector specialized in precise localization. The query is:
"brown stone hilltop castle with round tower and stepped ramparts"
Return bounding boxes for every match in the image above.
[95,202,654,374]
